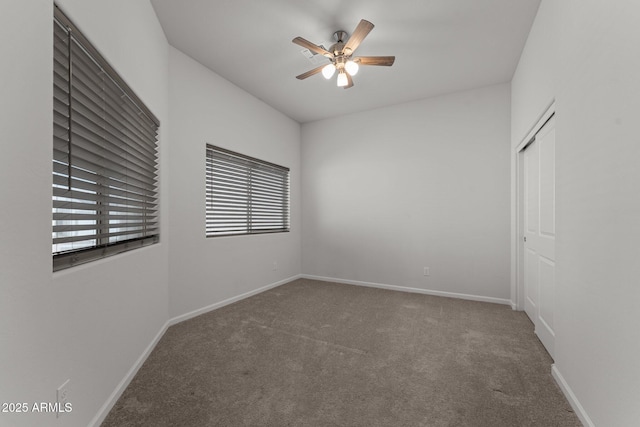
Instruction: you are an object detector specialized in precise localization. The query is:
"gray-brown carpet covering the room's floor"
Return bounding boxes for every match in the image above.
[103,279,581,427]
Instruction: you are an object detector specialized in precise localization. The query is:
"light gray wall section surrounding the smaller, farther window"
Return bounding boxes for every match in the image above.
[169,48,302,317]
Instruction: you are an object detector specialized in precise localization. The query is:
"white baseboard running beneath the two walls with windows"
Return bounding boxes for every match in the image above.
[89,274,302,427]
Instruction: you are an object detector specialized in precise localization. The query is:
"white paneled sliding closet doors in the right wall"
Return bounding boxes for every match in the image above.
[524,117,556,357]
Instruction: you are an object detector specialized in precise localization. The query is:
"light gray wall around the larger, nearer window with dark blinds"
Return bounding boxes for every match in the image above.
[0,0,169,426]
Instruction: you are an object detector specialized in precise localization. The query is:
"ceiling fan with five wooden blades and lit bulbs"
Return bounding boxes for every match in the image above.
[292,19,396,89]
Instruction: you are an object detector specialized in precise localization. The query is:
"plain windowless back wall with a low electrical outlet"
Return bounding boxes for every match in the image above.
[302,85,510,302]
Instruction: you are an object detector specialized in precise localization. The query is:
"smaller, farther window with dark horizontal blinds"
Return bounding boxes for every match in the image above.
[206,144,289,237]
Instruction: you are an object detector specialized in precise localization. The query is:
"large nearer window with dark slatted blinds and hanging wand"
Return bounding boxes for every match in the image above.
[52,7,159,271]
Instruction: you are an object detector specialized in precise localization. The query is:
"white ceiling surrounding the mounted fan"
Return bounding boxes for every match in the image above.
[151,0,540,123]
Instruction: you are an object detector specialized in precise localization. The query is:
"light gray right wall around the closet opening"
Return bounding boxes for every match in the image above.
[512,0,640,426]
